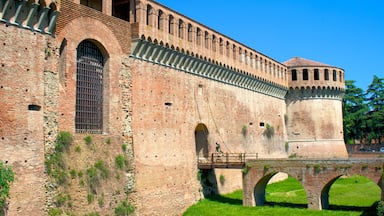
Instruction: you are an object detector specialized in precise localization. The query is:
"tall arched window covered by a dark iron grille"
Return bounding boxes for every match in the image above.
[75,41,104,133]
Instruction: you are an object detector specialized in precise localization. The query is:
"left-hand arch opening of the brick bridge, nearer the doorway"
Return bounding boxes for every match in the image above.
[254,172,308,208]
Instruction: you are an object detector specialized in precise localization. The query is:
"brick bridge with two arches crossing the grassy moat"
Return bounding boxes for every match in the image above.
[243,159,384,210]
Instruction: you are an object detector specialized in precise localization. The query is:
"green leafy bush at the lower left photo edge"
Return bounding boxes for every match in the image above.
[0,161,15,209]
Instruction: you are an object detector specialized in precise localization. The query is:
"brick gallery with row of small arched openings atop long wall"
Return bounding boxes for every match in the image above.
[130,0,287,87]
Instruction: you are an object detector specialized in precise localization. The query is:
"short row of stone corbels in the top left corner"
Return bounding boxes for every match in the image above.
[0,0,59,35]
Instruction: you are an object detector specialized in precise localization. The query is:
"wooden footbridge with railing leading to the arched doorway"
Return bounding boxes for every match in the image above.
[197,153,258,169]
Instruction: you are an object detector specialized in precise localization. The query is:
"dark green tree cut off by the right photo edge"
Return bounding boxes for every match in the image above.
[366,76,384,143]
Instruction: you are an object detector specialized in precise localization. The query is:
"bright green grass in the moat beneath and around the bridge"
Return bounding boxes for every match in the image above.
[183,176,381,216]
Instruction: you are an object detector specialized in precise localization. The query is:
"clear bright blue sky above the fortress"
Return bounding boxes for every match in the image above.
[157,0,384,90]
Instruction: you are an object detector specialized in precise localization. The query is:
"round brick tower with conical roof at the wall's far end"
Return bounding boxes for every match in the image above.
[284,57,348,158]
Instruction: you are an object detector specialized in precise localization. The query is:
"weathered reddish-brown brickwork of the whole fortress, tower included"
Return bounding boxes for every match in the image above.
[0,0,347,215]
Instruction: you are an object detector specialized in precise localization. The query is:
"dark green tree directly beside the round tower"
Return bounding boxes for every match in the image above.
[343,80,368,144]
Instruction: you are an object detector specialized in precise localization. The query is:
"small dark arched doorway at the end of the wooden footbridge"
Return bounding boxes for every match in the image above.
[195,123,209,159]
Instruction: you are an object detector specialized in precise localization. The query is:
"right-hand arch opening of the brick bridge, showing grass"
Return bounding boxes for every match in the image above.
[320,175,381,209]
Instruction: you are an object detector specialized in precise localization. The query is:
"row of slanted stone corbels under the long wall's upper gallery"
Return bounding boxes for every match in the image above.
[132,36,287,99]
